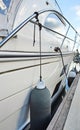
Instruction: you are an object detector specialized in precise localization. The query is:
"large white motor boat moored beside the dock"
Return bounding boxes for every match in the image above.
[0,0,80,130]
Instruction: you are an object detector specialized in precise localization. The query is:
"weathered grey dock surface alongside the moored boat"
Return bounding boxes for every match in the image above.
[46,74,80,130]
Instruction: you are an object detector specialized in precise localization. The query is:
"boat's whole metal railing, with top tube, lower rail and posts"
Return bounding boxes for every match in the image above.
[0,10,80,48]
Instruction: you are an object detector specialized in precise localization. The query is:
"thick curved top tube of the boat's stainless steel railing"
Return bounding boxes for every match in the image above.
[0,10,80,47]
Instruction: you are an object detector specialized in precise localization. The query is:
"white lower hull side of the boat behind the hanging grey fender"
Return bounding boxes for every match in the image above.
[0,51,73,130]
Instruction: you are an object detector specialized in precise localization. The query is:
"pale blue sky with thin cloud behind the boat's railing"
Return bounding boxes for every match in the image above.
[57,0,80,32]
